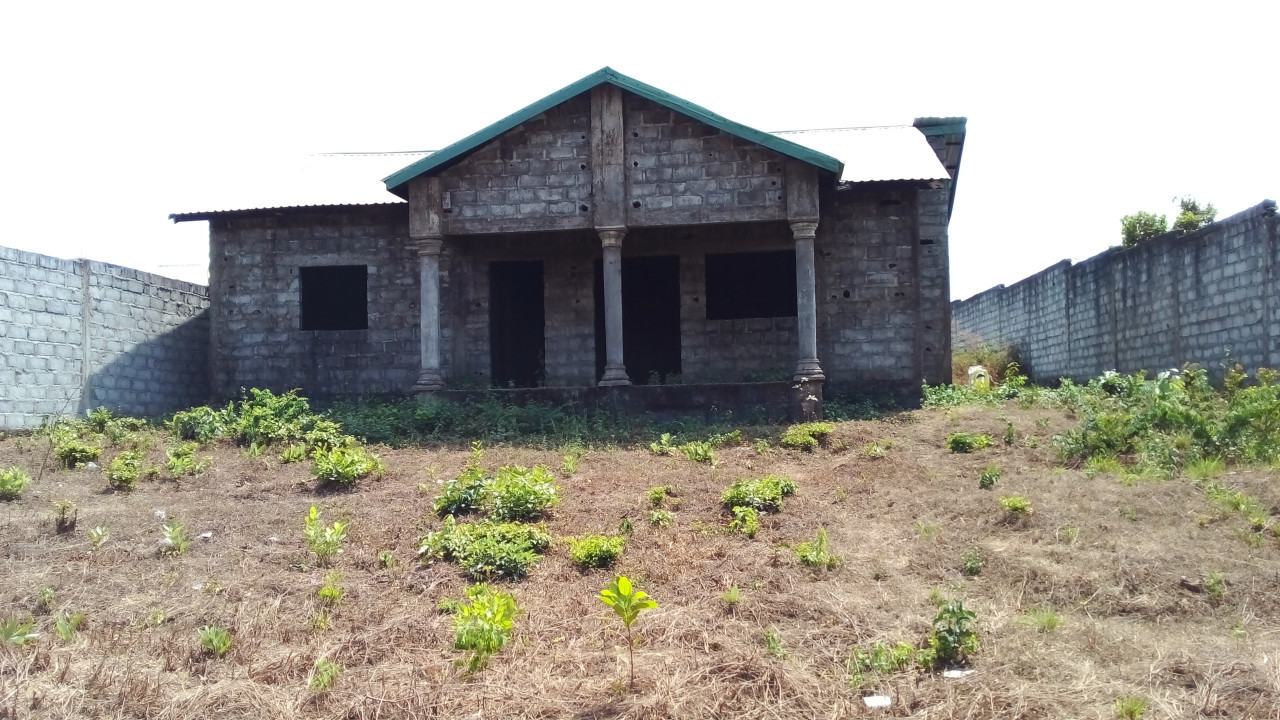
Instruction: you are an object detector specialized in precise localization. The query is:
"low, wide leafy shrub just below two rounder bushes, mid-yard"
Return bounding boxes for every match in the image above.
[417,515,552,579]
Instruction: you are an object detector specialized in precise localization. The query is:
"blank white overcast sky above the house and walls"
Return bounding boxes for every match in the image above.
[0,0,1280,297]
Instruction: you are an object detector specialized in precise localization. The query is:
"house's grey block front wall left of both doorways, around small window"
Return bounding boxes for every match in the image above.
[210,206,422,397]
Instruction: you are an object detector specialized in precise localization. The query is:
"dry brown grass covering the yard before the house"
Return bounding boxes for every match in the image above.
[0,407,1280,720]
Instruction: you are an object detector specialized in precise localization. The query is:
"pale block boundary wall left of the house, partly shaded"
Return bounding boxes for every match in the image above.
[0,247,209,429]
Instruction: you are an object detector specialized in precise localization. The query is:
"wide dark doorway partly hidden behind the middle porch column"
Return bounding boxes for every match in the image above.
[595,255,680,384]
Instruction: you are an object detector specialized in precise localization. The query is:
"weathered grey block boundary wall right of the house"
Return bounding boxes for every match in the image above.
[952,201,1280,382]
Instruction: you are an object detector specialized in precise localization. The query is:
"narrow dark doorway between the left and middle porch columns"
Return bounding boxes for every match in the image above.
[489,260,547,387]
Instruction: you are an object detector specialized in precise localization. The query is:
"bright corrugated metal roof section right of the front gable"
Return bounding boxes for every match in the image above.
[774,126,951,182]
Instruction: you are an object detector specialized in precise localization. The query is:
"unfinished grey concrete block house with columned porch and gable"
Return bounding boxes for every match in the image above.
[173,68,965,412]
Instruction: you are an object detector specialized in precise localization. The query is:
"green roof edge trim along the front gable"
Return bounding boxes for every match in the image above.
[383,68,844,197]
